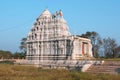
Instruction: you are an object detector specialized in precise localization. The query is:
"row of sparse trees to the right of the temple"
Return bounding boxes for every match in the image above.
[78,31,120,58]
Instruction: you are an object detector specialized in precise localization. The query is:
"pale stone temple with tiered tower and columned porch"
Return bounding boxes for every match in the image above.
[26,9,93,66]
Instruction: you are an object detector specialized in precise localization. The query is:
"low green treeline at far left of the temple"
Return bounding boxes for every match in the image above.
[0,50,25,59]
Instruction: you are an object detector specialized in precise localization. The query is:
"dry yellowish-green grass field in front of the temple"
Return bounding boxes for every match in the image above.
[0,64,120,80]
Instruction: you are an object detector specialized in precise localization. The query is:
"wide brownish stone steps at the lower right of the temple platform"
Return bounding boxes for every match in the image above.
[86,61,120,74]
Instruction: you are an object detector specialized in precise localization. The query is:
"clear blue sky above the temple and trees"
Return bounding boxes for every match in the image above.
[0,0,120,52]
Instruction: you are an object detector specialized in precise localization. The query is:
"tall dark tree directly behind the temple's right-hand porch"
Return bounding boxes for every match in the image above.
[80,31,102,57]
